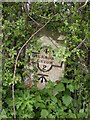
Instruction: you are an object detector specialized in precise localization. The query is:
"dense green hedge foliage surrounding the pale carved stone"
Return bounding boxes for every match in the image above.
[2,2,90,119]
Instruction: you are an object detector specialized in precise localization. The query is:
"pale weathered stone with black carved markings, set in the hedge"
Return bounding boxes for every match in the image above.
[24,30,65,89]
